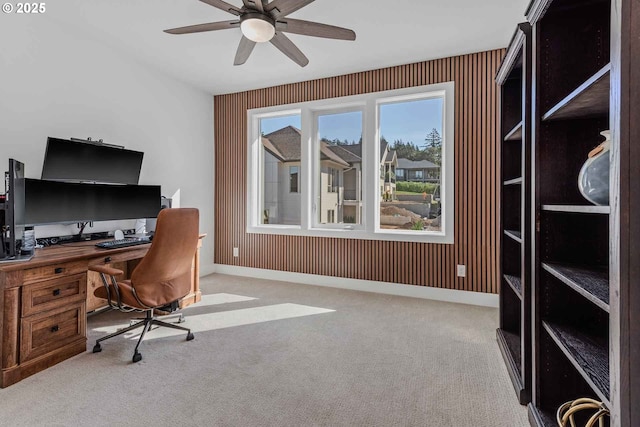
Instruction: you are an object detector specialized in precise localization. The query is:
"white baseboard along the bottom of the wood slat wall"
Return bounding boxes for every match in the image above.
[210,264,499,308]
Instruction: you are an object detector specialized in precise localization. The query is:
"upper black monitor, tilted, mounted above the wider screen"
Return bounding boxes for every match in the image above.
[42,137,144,184]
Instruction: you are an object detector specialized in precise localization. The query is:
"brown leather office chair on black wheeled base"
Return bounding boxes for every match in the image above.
[89,208,199,362]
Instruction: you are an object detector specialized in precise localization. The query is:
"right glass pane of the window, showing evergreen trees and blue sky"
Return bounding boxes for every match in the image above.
[379,97,443,231]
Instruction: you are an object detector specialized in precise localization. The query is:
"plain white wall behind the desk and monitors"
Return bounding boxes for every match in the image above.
[0,14,214,271]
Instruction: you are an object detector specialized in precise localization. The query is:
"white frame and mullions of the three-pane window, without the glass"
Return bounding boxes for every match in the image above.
[246,82,455,244]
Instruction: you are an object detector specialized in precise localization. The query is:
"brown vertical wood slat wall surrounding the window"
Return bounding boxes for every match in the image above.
[214,49,505,293]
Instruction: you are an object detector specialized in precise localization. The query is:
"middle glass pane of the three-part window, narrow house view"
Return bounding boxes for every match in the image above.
[315,111,362,224]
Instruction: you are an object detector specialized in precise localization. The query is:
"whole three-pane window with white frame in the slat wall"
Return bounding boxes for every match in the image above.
[247,82,455,243]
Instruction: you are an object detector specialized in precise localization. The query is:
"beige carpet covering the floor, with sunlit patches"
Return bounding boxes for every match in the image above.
[0,275,528,427]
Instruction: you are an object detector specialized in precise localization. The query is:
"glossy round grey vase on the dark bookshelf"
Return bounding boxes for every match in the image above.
[578,130,611,206]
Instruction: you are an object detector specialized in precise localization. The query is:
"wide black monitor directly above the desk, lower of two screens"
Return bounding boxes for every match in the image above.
[25,179,161,226]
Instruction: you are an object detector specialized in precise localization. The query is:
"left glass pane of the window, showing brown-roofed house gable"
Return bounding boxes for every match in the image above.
[260,114,302,225]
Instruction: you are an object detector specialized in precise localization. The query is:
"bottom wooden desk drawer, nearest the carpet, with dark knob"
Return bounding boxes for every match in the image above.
[20,301,87,363]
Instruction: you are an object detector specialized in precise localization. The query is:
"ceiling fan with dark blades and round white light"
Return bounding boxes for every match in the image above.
[164,0,356,67]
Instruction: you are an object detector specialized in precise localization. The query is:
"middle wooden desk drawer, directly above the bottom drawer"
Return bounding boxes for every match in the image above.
[22,273,87,317]
